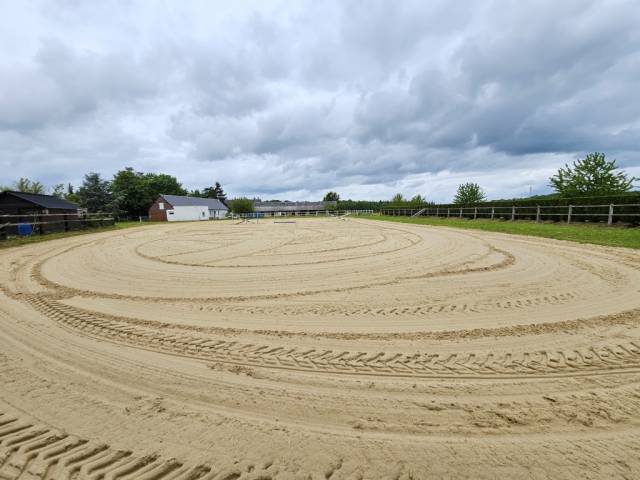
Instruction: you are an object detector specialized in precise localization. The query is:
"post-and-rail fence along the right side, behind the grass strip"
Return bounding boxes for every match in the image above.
[380,203,640,225]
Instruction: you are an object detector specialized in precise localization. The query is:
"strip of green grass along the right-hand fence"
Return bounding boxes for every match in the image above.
[367,215,640,249]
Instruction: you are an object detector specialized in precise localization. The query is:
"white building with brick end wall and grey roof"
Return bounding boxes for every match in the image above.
[149,195,229,222]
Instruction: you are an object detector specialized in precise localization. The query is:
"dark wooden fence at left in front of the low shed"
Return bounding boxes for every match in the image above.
[0,213,115,240]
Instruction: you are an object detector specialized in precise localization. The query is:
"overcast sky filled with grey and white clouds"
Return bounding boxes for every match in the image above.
[0,0,640,201]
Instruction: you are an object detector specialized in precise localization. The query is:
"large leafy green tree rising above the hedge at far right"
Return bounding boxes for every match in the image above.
[549,152,638,197]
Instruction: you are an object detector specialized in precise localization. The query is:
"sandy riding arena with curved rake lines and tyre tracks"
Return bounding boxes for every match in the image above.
[0,218,640,480]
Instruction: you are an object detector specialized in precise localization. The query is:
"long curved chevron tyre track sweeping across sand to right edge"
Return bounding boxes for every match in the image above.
[23,295,640,378]
